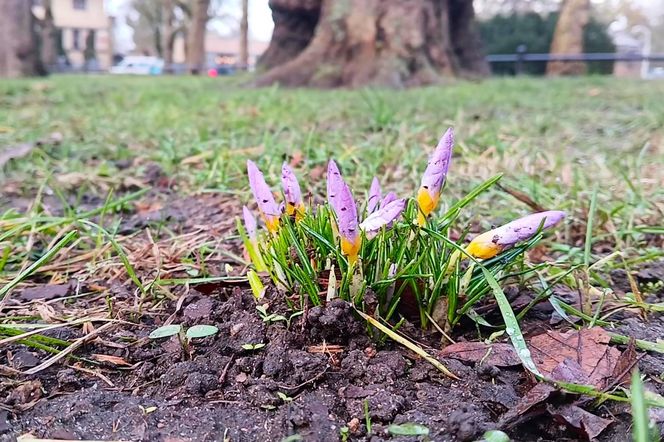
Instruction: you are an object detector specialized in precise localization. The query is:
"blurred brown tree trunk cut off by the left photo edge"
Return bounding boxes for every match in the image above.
[0,0,39,77]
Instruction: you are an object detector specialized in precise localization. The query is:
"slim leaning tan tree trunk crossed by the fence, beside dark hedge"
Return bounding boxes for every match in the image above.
[546,0,590,75]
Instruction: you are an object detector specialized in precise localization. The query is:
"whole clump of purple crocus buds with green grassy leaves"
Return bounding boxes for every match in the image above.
[239,128,564,334]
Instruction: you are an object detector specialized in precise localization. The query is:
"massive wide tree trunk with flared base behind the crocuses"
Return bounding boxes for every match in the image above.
[257,0,489,87]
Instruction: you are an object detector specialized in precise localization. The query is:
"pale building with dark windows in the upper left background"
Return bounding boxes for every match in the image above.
[34,0,113,70]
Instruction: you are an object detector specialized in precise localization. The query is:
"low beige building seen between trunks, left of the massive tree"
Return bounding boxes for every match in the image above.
[173,31,269,69]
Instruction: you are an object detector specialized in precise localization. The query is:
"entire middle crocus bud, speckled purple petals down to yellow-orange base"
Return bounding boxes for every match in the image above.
[327,160,362,264]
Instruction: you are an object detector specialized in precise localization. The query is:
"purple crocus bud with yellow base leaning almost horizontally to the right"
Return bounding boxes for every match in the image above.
[466,210,565,259]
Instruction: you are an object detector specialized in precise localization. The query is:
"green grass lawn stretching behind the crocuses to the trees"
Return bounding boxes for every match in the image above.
[0,76,664,286]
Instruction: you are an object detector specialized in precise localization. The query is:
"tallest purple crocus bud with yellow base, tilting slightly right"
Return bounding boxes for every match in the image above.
[417,127,454,226]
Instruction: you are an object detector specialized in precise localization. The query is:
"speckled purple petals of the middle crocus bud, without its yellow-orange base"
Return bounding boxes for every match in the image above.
[327,160,359,242]
